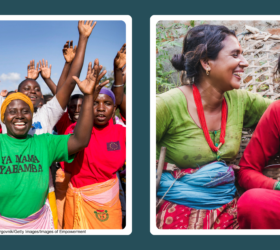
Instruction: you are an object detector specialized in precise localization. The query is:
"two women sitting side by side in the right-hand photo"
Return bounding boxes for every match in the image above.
[156,25,280,229]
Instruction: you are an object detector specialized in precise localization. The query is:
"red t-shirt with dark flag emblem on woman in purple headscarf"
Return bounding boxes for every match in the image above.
[65,119,126,188]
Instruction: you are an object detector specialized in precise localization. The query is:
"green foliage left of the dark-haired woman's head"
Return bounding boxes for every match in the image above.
[156,23,189,93]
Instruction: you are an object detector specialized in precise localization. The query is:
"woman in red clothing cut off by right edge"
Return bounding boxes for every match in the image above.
[237,57,280,229]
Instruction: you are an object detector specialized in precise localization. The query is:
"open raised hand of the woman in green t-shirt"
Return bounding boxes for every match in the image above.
[73,59,109,95]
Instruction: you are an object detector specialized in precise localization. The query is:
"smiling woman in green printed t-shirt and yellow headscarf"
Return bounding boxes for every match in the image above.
[0,61,104,229]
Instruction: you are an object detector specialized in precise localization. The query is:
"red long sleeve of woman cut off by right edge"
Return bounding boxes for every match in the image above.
[238,101,280,189]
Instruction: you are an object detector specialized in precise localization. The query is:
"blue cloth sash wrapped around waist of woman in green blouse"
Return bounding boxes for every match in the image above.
[157,162,236,210]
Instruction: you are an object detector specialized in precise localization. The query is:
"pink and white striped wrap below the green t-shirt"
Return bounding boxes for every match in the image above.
[0,200,54,229]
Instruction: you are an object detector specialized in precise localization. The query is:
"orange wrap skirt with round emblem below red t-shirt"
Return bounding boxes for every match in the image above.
[64,178,122,229]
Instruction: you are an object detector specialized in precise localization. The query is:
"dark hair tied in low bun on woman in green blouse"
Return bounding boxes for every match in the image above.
[171,24,236,84]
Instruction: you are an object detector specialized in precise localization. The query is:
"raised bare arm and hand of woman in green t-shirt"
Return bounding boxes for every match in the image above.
[68,60,109,155]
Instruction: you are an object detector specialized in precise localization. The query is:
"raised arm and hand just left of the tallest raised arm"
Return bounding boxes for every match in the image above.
[56,41,77,92]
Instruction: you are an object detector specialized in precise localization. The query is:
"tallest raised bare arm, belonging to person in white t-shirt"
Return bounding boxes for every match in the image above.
[56,21,96,109]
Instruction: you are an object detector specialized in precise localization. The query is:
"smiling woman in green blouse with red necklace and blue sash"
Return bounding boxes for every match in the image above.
[156,25,271,229]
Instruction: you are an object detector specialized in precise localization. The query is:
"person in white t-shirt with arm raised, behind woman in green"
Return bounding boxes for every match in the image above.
[0,21,96,228]
